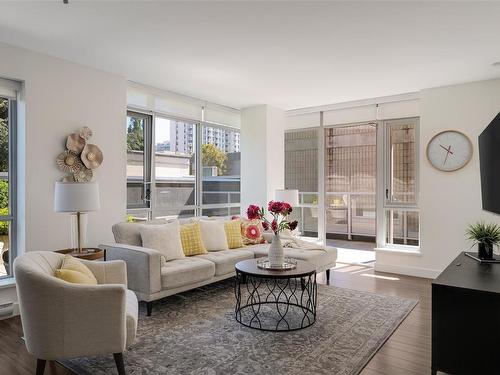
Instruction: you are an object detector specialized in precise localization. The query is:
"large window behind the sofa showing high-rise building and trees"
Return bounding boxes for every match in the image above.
[127,111,240,220]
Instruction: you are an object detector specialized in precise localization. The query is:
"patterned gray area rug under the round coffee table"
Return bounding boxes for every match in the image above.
[63,279,417,375]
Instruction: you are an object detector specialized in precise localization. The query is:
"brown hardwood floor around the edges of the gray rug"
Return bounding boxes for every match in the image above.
[0,264,431,375]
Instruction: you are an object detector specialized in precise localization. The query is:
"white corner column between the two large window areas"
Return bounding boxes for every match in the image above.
[241,105,285,214]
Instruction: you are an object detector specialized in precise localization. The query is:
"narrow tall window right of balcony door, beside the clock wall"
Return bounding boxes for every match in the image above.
[384,118,419,246]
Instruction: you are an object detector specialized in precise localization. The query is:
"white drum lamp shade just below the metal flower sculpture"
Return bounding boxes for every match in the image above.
[54,182,100,212]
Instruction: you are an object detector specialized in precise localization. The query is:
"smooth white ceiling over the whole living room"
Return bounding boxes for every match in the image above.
[0,0,500,109]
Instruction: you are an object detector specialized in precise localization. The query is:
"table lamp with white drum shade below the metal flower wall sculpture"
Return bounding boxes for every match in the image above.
[54,182,100,253]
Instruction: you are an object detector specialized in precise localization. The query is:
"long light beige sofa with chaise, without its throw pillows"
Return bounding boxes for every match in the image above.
[100,222,337,316]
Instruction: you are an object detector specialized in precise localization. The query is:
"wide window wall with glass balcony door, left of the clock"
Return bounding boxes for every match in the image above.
[285,114,420,247]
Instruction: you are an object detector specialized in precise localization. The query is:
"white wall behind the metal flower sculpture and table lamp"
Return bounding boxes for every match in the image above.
[0,44,126,258]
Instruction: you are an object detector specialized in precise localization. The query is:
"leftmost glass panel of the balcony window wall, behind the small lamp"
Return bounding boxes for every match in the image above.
[285,129,319,237]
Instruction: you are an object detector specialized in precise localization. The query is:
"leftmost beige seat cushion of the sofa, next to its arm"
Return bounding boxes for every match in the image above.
[160,256,215,289]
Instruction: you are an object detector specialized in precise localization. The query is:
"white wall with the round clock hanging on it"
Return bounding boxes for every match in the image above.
[376,80,500,277]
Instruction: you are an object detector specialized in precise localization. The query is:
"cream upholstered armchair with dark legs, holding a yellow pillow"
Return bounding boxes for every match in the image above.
[14,251,138,375]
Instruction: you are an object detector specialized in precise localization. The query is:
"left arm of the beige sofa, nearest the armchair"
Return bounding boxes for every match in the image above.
[99,243,161,295]
